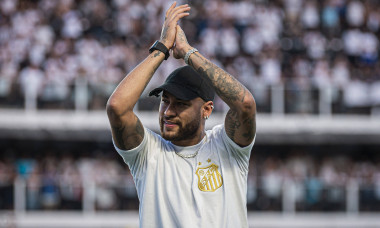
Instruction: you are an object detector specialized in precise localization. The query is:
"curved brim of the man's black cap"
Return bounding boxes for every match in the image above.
[149,83,198,101]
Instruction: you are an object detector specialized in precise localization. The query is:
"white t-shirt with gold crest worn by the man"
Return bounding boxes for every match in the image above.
[115,125,255,228]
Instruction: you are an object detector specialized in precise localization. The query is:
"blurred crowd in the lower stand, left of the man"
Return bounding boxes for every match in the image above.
[0,150,138,211]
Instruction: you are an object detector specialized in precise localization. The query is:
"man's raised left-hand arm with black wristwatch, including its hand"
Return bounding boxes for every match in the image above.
[107,2,190,150]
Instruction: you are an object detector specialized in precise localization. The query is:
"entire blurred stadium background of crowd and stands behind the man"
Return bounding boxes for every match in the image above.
[0,0,380,228]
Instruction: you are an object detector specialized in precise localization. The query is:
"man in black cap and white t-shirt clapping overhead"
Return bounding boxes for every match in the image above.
[107,2,256,228]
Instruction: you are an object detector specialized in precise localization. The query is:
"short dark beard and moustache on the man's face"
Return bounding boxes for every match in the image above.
[160,115,201,141]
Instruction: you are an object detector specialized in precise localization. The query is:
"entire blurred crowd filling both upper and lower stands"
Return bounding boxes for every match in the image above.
[0,0,380,215]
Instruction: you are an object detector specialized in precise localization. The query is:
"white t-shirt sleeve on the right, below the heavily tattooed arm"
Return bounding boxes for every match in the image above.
[220,124,256,173]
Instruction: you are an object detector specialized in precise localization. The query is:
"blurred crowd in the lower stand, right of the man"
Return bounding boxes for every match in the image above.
[248,147,380,211]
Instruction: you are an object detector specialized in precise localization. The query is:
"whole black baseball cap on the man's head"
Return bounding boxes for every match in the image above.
[149,66,215,101]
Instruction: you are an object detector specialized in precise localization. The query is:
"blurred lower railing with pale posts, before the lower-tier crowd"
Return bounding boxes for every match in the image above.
[0,176,380,214]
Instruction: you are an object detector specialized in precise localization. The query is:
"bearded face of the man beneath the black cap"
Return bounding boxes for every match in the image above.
[159,91,204,142]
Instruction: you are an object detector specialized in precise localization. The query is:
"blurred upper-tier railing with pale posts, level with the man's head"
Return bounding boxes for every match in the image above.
[0,80,380,116]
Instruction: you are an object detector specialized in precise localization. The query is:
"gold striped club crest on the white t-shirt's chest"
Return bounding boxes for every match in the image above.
[195,163,223,192]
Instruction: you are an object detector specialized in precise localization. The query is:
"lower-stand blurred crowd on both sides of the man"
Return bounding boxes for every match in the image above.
[0,147,380,211]
